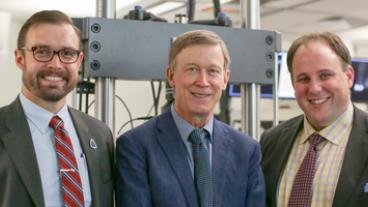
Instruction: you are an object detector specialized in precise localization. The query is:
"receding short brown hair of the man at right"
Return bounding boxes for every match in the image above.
[287,32,351,75]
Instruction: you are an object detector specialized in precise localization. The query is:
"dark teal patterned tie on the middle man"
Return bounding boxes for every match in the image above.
[189,129,213,207]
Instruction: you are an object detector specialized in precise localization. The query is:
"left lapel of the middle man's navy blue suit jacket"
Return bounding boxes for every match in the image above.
[156,109,198,207]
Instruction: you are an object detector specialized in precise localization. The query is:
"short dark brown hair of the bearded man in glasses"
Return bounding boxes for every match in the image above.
[17,10,82,49]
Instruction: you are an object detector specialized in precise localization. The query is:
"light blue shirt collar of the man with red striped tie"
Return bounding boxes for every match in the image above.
[19,93,68,134]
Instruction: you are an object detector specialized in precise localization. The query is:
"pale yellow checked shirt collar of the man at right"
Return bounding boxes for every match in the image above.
[300,102,354,145]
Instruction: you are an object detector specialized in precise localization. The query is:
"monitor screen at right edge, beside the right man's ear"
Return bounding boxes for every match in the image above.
[351,58,368,102]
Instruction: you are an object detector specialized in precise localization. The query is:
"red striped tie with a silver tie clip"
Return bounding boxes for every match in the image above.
[49,116,84,207]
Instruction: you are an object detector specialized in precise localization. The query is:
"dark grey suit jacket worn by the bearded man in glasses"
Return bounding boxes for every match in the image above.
[0,98,114,207]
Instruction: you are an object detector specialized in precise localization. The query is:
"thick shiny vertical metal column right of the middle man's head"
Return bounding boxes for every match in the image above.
[240,0,260,139]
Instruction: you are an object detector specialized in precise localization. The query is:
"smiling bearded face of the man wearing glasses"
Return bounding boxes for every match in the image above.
[15,23,83,111]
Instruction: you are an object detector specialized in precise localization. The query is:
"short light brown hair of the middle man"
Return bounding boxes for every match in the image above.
[169,30,230,69]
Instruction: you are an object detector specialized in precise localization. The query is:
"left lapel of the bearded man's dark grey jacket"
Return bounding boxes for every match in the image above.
[0,98,45,206]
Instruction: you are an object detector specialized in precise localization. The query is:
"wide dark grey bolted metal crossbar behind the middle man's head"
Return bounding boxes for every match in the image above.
[82,18,281,84]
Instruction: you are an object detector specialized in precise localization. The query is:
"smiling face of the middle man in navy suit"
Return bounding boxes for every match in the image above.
[167,44,230,127]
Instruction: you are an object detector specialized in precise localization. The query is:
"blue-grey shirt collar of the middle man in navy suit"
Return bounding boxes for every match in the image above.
[170,104,214,142]
